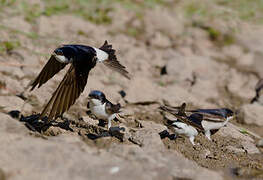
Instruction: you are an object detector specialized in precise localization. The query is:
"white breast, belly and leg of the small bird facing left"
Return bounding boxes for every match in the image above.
[90,99,116,129]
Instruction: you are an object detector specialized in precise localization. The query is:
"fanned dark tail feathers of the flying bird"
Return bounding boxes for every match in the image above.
[100,41,130,79]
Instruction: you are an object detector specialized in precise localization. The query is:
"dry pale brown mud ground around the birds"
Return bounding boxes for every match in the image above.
[0,1,263,180]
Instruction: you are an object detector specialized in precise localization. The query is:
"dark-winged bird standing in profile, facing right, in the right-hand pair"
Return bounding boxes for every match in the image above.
[162,106,234,140]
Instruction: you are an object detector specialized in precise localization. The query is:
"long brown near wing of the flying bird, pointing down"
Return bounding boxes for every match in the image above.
[40,65,89,121]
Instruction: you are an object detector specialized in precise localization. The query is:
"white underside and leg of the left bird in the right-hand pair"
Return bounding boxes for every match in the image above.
[173,122,198,145]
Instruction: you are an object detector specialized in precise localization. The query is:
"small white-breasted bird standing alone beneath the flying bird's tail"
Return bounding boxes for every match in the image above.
[88,90,121,130]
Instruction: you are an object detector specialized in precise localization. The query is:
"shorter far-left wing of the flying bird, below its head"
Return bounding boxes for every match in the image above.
[30,55,67,91]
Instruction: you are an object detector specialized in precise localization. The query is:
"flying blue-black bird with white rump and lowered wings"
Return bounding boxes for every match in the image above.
[30,41,129,122]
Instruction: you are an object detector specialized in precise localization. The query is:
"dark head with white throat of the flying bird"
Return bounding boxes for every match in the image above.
[52,46,75,63]
